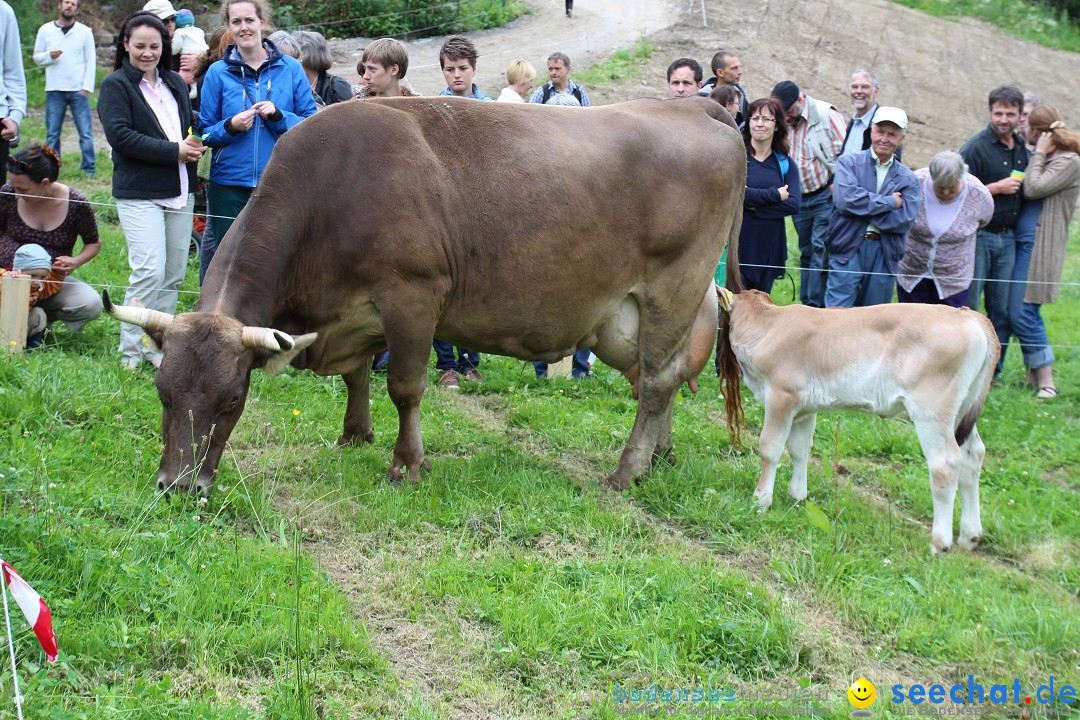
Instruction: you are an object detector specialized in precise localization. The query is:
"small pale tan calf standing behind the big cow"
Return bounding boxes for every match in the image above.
[718,290,1001,553]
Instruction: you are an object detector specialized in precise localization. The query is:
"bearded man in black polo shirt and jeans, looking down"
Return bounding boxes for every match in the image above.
[960,85,1028,356]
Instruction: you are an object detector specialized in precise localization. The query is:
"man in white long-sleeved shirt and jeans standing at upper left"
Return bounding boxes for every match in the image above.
[33,0,97,177]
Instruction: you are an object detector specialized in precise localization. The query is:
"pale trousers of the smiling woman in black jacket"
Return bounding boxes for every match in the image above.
[117,195,194,367]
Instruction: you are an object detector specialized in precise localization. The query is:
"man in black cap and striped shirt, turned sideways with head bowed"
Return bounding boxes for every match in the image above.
[772,80,845,308]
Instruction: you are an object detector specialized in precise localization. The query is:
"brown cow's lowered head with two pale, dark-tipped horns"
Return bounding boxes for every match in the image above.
[105,295,318,497]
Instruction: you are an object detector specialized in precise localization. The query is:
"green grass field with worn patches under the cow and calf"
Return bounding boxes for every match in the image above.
[0,71,1080,720]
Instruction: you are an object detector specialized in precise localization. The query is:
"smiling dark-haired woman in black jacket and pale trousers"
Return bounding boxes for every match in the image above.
[97,12,204,369]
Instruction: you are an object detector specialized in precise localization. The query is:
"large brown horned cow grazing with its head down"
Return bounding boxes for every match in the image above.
[105,97,746,494]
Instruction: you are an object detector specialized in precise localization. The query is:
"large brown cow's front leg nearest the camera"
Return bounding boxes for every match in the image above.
[387,336,431,483]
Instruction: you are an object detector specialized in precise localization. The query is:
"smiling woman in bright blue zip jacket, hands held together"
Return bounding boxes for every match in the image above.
[199,0,316,274]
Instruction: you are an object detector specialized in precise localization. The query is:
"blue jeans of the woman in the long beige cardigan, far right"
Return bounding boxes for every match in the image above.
[997,200,1054,372]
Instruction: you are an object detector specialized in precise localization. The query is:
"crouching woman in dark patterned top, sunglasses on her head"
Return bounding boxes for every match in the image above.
[0,142,102,332]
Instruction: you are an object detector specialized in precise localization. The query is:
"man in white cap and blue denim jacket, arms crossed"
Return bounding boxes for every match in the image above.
[825,106,922,308]
